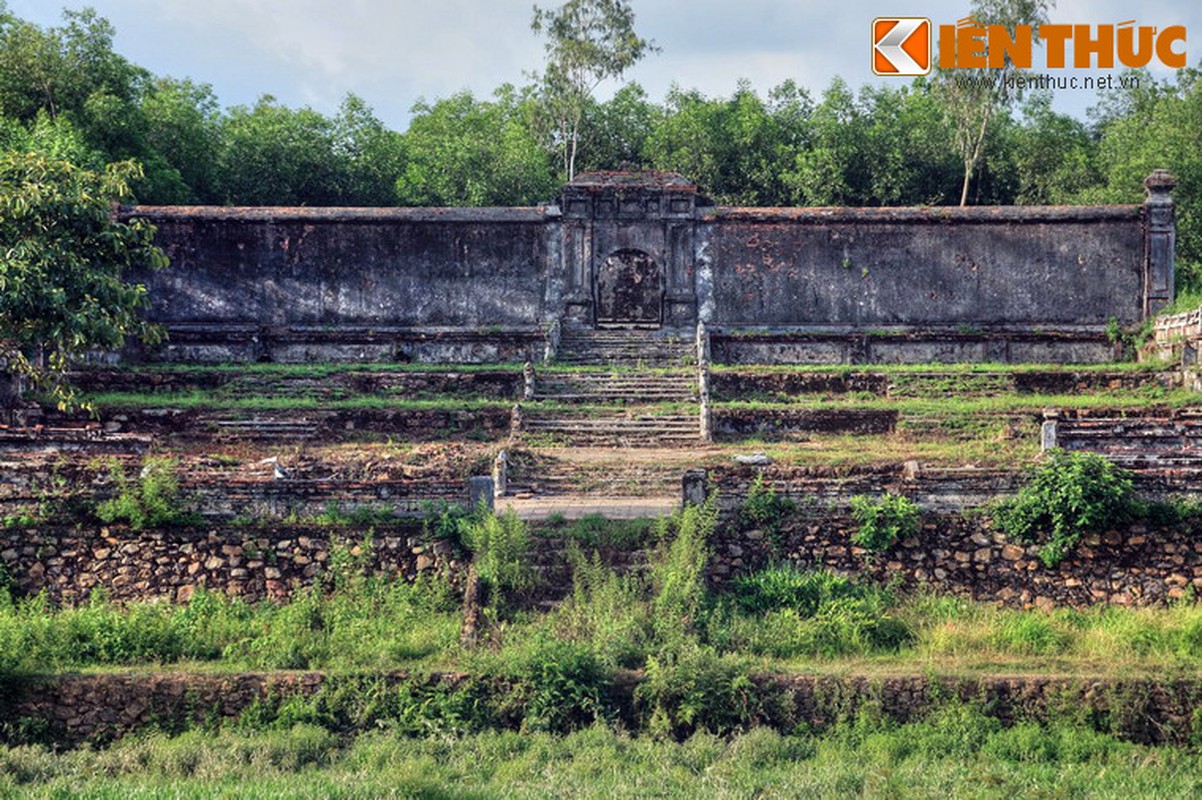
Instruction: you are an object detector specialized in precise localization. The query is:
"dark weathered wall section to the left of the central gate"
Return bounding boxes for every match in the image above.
[123,207,547,327]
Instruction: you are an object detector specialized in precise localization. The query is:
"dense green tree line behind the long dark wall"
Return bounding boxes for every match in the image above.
[0,0,1202,288]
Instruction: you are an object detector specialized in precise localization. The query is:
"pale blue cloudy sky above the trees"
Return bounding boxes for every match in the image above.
[7,0,1202,130]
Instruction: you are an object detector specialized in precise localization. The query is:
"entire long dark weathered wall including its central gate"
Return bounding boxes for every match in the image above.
[123,171,1174,364]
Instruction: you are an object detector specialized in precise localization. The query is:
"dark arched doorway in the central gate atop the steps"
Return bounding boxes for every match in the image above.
[594,250,664,328]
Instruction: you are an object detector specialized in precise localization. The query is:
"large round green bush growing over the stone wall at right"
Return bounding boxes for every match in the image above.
[992,450,1133,568]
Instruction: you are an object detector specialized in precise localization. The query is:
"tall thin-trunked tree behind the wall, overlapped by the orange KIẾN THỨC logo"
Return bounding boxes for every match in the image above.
[936,0,1055,205]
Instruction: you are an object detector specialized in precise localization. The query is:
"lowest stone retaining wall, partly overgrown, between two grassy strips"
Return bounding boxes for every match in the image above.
[0,673,1202,747]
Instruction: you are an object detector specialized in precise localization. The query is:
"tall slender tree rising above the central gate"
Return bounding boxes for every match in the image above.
[530,0,659,180]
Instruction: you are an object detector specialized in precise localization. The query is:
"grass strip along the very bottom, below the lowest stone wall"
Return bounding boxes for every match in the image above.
[0,708,1202,800]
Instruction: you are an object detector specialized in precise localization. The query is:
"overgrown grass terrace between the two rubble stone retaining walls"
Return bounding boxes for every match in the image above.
[11,547,1202,677]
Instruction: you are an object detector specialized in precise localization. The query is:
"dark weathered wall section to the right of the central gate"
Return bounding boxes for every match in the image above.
[703,207,1144,327]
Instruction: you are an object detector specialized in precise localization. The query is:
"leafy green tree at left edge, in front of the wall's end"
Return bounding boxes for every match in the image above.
[0,151,167,408]
